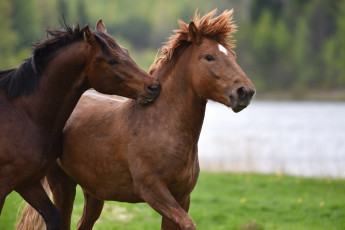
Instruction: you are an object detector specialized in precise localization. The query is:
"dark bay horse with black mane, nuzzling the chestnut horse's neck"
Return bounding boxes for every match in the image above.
[0,20,160,229]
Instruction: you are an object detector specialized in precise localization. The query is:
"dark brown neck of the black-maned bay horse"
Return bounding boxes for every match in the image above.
[20,41,89,137]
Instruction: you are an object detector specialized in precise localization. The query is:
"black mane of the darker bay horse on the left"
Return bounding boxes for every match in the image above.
[0,20,115,99]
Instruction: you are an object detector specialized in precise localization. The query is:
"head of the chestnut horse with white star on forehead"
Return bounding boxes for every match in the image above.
[184,11,255,112]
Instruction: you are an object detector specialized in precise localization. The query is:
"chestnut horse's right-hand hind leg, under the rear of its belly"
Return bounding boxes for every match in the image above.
[77,190,104,230]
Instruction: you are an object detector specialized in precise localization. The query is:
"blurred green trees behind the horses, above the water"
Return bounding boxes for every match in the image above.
[0,0,345,94]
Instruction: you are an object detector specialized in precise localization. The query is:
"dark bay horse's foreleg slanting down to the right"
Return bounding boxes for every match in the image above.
[16,181,60,230]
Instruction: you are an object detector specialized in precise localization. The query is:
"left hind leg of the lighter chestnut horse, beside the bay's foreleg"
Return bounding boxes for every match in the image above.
[46,162,77,230]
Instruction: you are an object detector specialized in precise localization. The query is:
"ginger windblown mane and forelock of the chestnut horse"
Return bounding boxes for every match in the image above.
[149,9,237,74]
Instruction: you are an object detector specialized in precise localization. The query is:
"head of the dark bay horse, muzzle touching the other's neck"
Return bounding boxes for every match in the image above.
[82,19,160,103]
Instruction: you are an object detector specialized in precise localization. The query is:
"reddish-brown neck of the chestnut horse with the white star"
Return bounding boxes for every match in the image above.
[156,48,207,140]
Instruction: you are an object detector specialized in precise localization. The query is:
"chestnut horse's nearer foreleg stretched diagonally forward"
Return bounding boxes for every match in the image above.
[136,184,196,230]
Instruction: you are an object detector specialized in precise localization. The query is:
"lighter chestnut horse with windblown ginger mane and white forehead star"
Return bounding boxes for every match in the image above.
[22,10,255,230]
